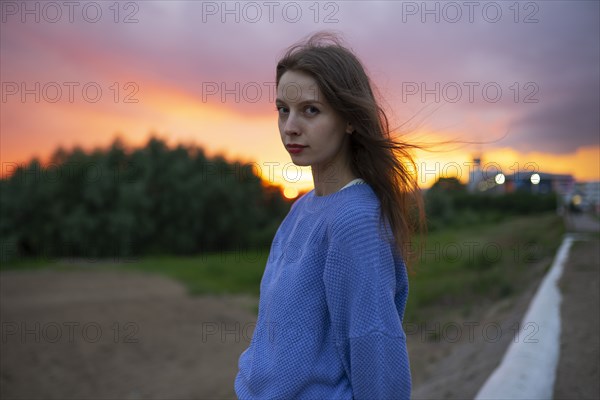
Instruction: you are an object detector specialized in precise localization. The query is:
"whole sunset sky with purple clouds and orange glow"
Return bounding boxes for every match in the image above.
[0,1,600,194]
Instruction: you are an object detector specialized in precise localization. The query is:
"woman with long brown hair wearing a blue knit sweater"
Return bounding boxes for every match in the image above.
[235,33,423,399]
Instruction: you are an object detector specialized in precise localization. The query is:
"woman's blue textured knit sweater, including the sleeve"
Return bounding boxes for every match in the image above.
[235,184,411,399]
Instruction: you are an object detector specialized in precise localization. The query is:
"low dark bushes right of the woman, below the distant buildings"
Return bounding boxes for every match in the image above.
[425,178,557,231]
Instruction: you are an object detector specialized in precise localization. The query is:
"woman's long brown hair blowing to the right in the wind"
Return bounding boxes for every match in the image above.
[276,31,425,258]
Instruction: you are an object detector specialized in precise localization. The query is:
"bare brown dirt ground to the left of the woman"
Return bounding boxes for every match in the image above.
[0,271,255,399]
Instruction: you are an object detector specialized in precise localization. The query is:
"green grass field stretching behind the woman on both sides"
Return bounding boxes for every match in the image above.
[2,214,564,322]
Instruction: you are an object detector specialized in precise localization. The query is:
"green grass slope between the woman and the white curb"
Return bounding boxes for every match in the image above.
[405,214,564,322]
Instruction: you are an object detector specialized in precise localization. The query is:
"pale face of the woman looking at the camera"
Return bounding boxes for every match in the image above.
[276,71,352,172]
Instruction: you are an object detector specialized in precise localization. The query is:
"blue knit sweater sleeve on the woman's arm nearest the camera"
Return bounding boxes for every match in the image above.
[323,211,411,400]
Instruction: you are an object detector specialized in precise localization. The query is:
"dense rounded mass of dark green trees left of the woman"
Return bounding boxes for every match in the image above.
[0,138,290,261]
